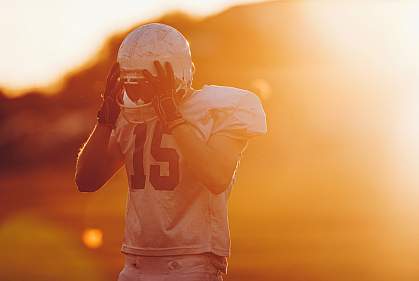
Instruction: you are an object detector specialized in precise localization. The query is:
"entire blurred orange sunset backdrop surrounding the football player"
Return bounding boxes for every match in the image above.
[0,0,419,281]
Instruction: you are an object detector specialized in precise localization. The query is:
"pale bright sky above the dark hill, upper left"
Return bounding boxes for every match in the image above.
[0,0,257,90]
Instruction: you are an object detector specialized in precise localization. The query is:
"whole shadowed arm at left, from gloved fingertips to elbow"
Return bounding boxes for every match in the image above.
[75,63,123,192]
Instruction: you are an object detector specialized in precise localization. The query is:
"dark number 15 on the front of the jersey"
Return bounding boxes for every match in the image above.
[131,122,179,190]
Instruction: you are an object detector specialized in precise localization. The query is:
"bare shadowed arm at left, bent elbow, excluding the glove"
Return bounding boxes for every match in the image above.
[75,124,123,192]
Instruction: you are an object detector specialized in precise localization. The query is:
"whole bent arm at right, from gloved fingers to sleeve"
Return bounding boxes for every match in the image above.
[143,61,251,194]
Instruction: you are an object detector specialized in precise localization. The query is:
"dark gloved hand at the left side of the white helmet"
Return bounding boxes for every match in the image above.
[97,63,122,128]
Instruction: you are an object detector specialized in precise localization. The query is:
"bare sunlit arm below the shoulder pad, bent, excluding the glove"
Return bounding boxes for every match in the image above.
[172,123,247,194]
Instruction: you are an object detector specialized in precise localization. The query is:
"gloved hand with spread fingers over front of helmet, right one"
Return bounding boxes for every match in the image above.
[143,61,185,132]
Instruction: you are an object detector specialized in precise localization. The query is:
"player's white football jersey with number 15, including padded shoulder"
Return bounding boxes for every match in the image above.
[112,83,266,257]
